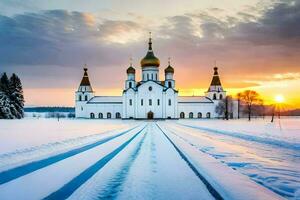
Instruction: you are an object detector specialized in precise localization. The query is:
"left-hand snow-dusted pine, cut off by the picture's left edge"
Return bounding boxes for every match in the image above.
[0,73,14,119]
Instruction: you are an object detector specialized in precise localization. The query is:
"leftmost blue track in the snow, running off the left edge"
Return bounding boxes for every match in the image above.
[0,126,138,185]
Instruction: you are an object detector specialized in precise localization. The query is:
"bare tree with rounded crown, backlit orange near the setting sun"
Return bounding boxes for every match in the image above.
[241,90,261,121]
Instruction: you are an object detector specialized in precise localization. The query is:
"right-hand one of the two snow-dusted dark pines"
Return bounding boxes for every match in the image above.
[9,74,24,119]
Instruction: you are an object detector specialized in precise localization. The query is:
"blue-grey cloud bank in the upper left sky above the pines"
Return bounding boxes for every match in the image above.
[0,10,142,65]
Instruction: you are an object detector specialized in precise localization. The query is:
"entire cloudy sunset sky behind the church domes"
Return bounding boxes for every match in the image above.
[0,0,300,108]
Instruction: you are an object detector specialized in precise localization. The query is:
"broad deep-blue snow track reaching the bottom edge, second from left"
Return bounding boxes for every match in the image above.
[44,126,146,200]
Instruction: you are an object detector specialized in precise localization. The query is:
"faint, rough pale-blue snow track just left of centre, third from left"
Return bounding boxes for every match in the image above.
[97,127,148,199]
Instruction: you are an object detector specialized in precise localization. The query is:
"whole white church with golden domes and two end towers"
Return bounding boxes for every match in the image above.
[75,37,237,119]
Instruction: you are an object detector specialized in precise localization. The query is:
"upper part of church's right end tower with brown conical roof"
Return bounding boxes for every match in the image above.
[205,64,226,101]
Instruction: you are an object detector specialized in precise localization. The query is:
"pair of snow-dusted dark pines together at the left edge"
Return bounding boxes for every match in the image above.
[0,73,25,119]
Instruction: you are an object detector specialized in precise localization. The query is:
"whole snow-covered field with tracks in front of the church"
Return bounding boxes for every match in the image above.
[0,118,300,200]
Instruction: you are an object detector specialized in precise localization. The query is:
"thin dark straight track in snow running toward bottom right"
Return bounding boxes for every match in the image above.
[155,123,223,200]
